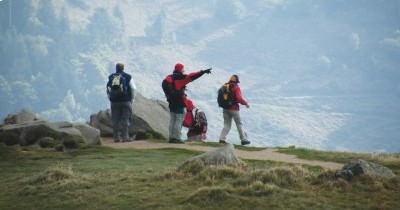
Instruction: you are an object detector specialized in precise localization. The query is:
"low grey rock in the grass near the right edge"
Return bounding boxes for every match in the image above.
[335,159,395,180]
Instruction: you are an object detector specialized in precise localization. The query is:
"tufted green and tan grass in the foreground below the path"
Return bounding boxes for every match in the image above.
[0,144,400,210]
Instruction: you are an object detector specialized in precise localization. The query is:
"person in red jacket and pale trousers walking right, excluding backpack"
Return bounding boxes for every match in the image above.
[219,75,250,145]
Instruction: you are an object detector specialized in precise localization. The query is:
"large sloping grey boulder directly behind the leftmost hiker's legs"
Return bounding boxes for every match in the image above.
[89,94,169,139]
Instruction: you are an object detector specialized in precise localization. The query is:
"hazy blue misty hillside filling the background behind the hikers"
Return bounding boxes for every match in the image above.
[0,0,400,152]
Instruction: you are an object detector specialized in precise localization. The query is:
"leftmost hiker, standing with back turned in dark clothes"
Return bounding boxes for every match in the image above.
[107,63,136,142]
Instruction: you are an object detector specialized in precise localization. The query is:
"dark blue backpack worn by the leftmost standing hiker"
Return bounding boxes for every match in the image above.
[107,73,129,101]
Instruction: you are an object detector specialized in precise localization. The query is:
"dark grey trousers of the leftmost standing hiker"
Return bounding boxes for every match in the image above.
[111,101,132,140]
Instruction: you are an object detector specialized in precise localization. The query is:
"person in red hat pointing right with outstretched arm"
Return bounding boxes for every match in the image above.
[163,63,211,143]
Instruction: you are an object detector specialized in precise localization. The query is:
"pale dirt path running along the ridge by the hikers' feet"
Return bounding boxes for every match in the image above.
[102,138,343,170]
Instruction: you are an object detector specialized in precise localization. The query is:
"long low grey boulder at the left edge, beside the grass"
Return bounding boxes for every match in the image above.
[0,121,100,147]
